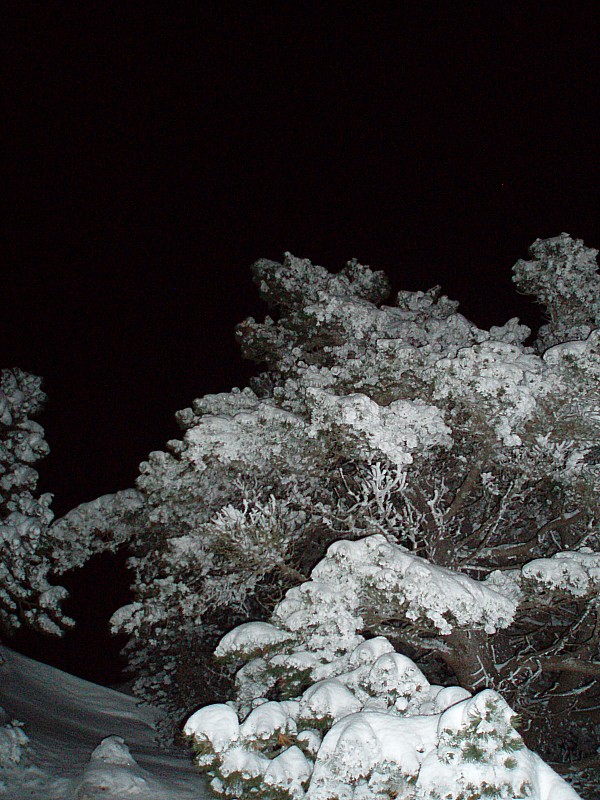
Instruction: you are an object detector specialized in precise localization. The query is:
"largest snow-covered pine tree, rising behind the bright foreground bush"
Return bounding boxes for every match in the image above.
[114,236,600,780]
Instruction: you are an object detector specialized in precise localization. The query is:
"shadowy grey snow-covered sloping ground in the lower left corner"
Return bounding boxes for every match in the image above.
[0,647,210,800]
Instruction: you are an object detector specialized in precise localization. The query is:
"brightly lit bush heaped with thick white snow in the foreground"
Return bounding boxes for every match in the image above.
[184,535,577,800]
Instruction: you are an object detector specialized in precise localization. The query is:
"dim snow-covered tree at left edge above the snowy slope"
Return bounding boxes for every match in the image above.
[0,368,143,635]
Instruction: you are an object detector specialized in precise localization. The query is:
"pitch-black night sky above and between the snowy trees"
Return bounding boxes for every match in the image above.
[0,2,600,682]
